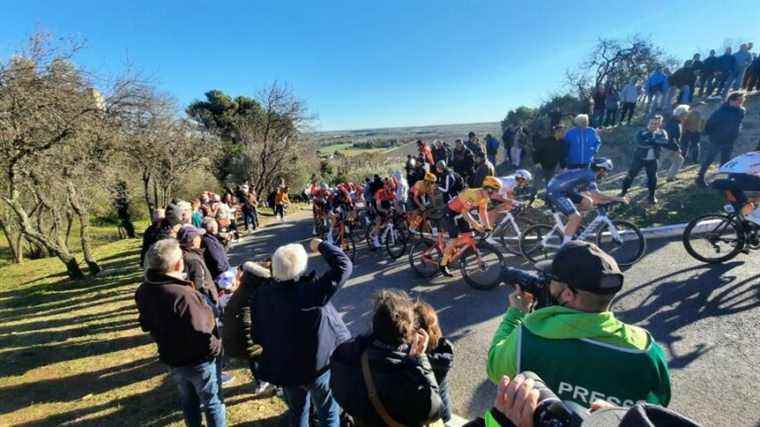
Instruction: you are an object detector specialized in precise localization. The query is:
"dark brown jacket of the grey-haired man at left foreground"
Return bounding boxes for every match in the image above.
[135,270,222,367]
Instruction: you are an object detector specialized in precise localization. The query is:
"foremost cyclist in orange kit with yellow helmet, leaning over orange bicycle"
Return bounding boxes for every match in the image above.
[439,176,502,277]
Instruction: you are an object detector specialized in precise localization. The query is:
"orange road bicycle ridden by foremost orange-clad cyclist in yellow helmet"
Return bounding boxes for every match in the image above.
[409,227,504,290]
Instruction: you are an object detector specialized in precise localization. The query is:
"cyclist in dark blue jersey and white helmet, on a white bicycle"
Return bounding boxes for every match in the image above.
[546,157,628,244]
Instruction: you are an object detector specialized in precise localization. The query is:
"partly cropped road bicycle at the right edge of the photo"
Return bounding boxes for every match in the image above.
[682,200,760,264]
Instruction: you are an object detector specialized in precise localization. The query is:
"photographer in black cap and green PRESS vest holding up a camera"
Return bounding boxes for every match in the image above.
[488,241,670,407]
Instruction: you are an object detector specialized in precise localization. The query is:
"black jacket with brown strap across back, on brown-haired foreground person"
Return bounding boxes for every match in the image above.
[330,336,441,427]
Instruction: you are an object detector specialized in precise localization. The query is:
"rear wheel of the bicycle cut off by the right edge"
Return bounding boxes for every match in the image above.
[683,215,745,264]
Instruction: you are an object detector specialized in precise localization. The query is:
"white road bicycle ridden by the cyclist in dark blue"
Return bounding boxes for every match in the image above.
[520,200,646,266]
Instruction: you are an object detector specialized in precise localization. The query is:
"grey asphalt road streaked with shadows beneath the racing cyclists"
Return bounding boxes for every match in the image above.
[234,212,760,426]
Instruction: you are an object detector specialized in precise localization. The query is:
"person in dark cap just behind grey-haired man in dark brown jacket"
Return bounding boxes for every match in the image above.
[177,227,219,314]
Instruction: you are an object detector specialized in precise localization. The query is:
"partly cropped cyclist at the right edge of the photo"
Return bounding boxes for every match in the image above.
[712,150,760,225]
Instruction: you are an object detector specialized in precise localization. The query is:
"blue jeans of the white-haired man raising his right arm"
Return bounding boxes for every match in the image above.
[284,370,340,427]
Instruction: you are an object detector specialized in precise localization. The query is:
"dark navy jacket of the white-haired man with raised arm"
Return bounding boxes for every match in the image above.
[251,242,353,386]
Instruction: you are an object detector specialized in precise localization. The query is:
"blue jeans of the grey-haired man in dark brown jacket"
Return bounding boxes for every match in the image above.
[170,359,227,427]
